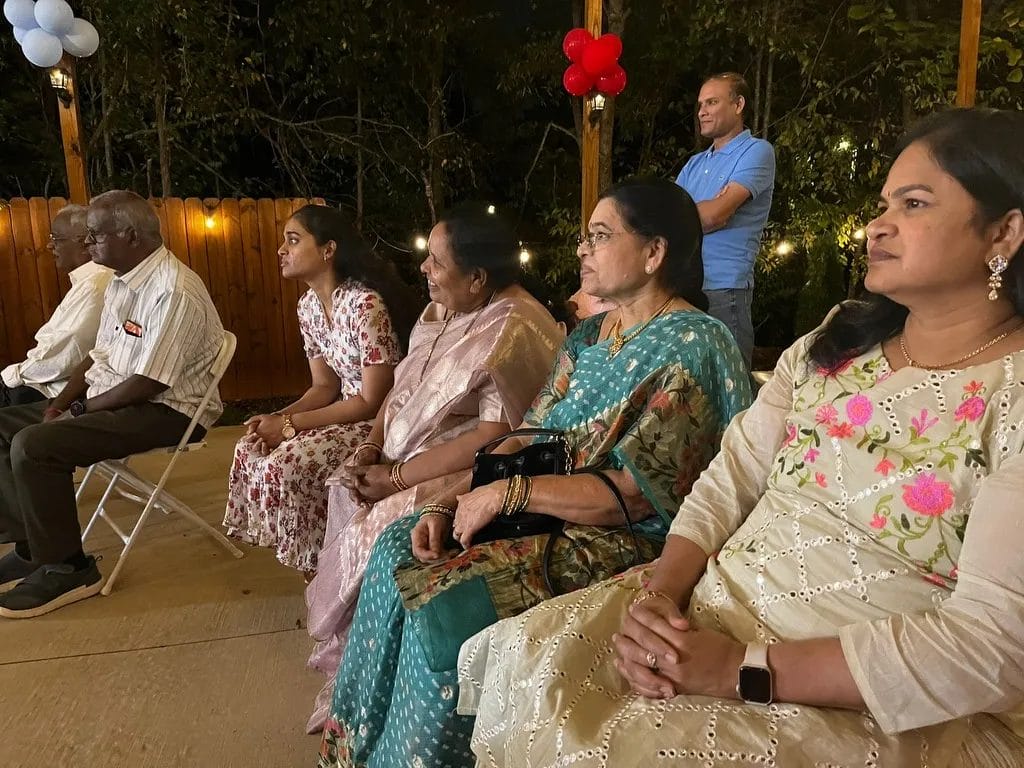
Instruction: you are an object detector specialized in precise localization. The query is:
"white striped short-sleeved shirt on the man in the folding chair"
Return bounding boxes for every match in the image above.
[85,246,224,428]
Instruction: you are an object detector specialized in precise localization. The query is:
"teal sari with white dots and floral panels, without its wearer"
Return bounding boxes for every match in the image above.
[319,311,751,768]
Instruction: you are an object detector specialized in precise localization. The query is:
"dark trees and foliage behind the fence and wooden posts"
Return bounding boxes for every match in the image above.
[0,0,1024,346]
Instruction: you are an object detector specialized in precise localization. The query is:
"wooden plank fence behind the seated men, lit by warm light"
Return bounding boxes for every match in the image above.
[0,198,322,400]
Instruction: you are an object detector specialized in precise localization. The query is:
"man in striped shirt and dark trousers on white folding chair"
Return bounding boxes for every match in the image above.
[0,190,224,618]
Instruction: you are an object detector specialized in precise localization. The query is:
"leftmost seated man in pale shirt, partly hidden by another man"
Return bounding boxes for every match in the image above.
[0,205,113,408]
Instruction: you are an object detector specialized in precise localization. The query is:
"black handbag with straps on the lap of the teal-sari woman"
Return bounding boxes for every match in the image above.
[470,429,640,595]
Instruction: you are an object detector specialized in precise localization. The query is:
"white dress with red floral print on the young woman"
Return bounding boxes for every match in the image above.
[224,281,400,571]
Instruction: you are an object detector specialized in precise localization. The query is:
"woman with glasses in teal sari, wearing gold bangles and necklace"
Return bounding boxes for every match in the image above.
[319,180,751,768]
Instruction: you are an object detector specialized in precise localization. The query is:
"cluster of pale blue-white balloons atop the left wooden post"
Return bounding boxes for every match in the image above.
[3,0,99,67]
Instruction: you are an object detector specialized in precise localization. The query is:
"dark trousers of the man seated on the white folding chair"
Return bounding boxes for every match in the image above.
[0,402,205,564]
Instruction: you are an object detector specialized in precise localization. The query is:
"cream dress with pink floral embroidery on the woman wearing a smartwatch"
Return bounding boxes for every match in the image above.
[459,331,1024,768]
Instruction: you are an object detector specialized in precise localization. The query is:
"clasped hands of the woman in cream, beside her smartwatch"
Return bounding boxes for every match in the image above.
[611,594,745,698]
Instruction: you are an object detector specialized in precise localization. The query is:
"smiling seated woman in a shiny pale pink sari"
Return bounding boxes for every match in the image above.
[306,207,563,732]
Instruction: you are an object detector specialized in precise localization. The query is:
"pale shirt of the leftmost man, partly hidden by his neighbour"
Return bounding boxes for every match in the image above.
[0,261,114,397]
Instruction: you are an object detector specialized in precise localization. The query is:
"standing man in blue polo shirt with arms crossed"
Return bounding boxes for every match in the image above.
[676,72,775,368]
